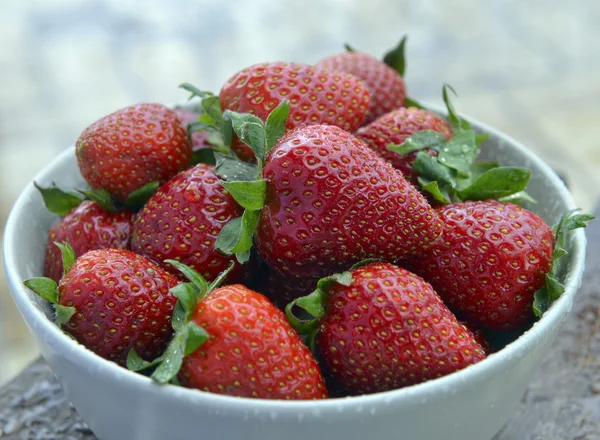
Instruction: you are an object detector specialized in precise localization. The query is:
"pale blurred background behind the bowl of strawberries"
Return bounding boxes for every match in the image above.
[0,0,600,383]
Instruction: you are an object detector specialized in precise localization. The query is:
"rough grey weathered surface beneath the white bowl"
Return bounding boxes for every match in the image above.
[0,210,600,440]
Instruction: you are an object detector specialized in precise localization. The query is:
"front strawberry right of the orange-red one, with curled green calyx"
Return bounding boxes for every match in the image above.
[286,262,485,395]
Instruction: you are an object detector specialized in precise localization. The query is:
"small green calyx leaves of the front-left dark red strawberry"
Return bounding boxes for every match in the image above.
[23,242,76,327]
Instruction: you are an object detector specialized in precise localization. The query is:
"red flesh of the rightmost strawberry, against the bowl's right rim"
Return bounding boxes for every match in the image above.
[411,200,554,330]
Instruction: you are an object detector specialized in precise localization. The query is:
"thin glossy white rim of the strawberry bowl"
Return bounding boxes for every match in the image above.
[3,110,586,415]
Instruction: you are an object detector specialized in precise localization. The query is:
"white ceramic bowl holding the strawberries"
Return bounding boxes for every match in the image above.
[4,111,585,440]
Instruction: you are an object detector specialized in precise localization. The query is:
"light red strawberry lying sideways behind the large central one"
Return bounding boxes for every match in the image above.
[219,63,369,160]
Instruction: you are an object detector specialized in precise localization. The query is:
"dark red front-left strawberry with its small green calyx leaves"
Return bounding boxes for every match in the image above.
[25,248,177,365]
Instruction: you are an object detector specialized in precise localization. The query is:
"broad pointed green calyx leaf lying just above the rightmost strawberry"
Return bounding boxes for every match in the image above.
[458,167,531,200]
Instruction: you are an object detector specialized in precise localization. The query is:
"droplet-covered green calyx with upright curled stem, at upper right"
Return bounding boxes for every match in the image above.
[387,85,535,204]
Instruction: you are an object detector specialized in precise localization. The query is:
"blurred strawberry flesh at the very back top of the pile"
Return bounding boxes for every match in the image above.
[317,52,406,125]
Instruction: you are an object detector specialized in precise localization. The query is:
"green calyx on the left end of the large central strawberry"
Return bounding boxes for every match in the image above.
[215,100,290,263]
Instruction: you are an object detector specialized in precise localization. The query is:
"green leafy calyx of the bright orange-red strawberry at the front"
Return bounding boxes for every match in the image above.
[127,260,234,384]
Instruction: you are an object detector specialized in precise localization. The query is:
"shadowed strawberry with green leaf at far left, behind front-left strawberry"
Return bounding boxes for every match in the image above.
[34,182,134,283]
